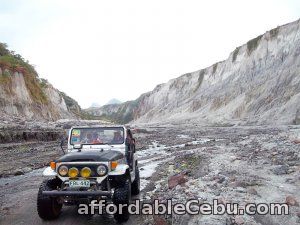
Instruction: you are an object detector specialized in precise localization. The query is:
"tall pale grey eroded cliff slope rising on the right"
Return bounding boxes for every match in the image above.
[85,20,300,125]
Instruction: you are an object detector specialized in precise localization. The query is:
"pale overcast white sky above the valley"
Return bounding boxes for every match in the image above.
[0,0,300,108]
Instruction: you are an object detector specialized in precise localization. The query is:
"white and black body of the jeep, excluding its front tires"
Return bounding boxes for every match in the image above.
[42,126,139,203]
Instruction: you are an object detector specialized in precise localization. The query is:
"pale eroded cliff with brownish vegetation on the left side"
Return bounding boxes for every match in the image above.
[0,68,76,120]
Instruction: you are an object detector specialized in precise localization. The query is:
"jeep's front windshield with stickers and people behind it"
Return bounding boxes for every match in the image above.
[70,127,124,145]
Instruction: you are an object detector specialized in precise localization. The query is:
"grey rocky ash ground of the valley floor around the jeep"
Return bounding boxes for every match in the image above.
[0,126,300,225]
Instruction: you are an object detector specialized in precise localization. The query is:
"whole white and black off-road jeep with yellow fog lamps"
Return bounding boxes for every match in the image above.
[37,126,140,222]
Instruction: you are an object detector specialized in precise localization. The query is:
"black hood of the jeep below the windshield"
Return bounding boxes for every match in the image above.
[56,150,124,162]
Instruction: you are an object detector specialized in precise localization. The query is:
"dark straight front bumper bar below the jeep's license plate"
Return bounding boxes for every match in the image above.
[43,191,114,198]
